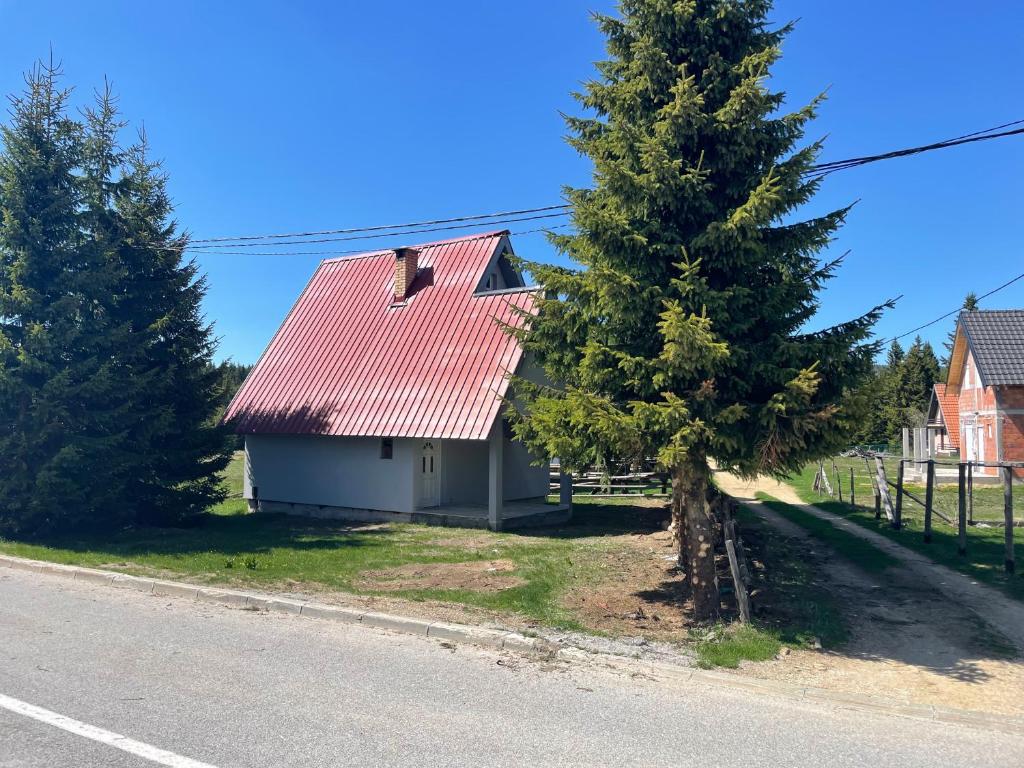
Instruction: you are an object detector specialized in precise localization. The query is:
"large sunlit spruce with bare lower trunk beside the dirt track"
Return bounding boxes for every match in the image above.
[510,0,881,618]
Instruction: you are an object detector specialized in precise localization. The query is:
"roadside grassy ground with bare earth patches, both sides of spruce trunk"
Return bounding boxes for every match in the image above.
[0,455,856,667]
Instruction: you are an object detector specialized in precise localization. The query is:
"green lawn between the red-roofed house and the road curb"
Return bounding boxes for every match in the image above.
[0,454,660,630]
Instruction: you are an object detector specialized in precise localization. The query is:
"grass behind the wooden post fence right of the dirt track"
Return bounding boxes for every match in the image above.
[790,458,1024,600]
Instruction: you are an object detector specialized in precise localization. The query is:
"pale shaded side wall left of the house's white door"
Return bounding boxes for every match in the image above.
[244,435,419,512]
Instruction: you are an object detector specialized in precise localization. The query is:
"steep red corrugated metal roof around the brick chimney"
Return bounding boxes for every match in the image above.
[225,232,532,439]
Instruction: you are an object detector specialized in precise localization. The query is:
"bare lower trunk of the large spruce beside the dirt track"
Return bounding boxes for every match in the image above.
[672,459,721,622]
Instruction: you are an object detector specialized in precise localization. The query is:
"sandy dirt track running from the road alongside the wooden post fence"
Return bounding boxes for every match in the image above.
[716,474,1024,715]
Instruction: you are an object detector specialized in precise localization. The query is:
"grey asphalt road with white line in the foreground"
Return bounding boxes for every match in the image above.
[0,569,1024,768]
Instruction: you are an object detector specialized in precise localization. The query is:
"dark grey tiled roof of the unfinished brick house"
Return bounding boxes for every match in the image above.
[959,309,1024,387]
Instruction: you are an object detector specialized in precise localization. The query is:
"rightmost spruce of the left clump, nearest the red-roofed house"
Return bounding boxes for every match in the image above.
[100,126,232,523]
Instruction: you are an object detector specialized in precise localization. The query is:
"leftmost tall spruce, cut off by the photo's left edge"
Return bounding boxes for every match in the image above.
[0,65,132,530]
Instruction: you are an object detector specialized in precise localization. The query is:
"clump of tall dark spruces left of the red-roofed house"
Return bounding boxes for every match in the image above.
[0,66,229,532]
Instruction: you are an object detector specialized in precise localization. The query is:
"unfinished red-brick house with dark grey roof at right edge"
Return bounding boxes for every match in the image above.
[945,309,1024,475]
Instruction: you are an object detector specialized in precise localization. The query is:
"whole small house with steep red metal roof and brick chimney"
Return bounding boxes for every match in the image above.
[225,231,569,529]
